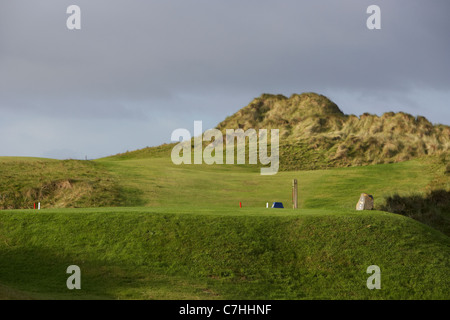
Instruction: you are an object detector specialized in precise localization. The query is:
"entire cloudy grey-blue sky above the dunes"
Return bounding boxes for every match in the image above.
[0,0,450,159]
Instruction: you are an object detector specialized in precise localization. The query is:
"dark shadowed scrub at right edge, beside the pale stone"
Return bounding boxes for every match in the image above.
[380,189,450,236]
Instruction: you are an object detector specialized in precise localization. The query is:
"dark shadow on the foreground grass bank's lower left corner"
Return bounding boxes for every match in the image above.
[0,247,117,300]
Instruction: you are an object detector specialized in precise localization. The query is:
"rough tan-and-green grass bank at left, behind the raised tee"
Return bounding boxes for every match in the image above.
[0,157,120,209]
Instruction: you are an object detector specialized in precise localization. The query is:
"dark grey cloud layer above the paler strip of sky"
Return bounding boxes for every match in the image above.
[1,1,450,97]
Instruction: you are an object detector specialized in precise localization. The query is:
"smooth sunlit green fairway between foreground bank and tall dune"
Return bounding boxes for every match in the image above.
[98,154,444,209]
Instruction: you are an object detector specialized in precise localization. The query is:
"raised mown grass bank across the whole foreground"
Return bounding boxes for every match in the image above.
[0,205,450,299]
